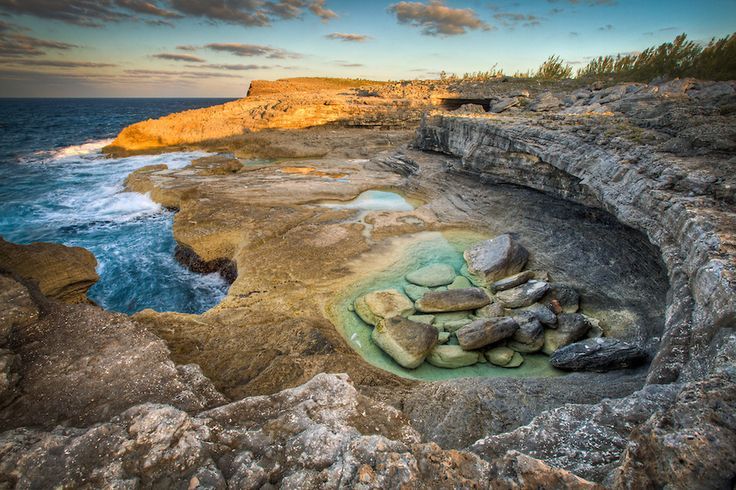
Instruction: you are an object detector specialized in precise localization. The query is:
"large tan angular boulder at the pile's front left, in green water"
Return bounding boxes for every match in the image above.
[371,316,439,369]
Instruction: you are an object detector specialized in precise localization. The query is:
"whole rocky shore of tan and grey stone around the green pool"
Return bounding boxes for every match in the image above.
[0,75,736,489]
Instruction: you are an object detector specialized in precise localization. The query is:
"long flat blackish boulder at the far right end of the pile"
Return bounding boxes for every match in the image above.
[550,338,648,372]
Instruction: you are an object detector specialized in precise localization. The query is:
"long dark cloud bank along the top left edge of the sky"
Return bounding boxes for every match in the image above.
[0,0,337,27]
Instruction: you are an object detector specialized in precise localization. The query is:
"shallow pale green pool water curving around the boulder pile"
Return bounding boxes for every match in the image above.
[330,232,564,381]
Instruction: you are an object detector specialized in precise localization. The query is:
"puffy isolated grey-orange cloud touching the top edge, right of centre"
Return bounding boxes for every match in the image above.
[388,0,491,36]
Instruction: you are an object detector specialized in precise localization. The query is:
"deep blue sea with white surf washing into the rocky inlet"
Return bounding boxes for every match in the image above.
[0,99,230,313]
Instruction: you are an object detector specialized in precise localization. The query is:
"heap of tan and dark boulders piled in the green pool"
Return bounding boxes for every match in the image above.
[354,234,647,371]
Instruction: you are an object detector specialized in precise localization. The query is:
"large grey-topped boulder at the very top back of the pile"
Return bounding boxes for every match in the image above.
[463,234,529,283]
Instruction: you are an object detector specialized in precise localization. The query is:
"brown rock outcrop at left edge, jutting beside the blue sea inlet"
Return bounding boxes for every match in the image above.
[0,238,99,303]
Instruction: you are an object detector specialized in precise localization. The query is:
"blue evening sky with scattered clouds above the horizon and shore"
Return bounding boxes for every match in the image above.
[0,0,736,97]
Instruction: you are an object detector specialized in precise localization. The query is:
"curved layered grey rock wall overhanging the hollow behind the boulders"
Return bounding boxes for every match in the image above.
[415,115,736,383]
